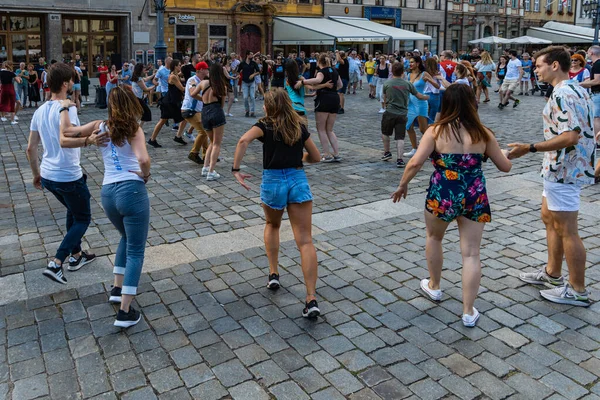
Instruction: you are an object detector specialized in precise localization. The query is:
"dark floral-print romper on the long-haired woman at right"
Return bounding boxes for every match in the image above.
[425,152,492,222]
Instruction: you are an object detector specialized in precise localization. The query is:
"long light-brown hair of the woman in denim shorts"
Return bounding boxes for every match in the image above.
[260,88,305,146]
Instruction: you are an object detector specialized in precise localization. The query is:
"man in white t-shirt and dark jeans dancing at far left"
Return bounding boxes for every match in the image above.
[27,63,106,284]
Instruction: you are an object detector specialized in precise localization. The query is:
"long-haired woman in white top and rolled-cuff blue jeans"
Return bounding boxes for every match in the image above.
[61,86,150,328]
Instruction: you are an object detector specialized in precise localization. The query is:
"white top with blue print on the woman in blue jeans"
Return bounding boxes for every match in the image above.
[100,122,144,185]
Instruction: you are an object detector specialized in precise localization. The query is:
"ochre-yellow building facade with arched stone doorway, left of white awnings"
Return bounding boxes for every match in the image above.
[165,0,323,57]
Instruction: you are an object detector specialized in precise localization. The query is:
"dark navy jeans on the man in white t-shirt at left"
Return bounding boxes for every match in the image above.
[42,175,92,263]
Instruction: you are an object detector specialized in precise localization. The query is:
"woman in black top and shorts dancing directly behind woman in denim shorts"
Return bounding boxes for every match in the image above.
[302,54,343,162]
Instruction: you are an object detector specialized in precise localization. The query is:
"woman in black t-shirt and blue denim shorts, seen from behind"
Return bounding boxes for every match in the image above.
[231,90,321,318]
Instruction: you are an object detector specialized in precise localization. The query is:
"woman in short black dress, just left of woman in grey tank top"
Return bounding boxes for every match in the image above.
[148,60,187,147]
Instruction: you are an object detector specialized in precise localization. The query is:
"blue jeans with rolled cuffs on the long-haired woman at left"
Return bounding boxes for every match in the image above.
[101,181,150,296]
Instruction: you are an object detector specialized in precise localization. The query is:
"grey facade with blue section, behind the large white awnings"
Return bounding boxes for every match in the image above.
[324,0,446,54]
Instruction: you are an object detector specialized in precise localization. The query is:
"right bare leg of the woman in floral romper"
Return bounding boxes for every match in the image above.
[457,217,485,315]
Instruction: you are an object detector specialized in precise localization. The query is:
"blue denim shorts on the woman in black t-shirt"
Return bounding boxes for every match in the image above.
[260,168,313,210]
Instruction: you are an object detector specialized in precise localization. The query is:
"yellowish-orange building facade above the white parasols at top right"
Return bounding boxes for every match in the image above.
[523,0,576,34]
